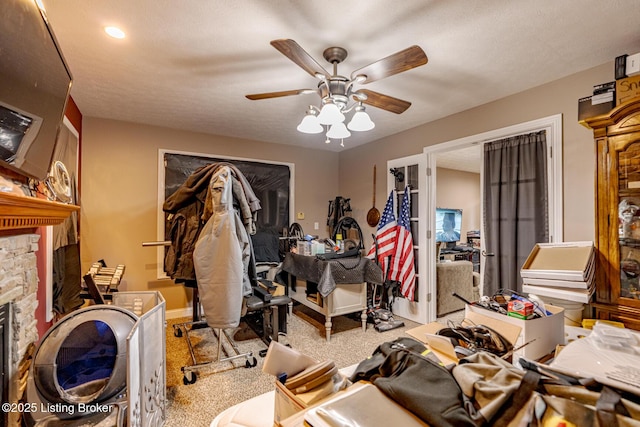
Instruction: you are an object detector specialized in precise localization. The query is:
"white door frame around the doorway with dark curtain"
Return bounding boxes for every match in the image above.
[420,114,564,321]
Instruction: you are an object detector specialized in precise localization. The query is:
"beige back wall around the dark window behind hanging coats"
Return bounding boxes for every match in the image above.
[80,117,339,310]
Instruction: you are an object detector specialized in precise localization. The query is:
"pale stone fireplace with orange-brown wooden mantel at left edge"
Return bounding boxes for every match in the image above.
[0,192,79,425]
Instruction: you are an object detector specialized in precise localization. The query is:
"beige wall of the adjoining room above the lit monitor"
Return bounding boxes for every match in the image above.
[436,168,481,243]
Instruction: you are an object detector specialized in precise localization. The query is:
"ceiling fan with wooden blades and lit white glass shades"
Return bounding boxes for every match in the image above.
[246,39,427,142]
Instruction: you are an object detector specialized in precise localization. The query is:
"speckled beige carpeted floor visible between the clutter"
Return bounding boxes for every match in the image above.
[165,305,436,427]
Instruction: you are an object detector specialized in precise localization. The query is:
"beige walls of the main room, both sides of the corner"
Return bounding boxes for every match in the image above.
[81,63,613,309]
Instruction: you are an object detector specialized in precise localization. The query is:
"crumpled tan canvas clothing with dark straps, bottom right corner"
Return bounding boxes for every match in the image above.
[453,352,640,427]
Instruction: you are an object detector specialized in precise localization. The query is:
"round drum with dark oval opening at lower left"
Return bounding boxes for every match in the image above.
[32,305,137,404]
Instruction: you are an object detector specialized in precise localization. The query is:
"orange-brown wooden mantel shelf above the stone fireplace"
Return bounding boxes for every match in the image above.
[0,192,80,231]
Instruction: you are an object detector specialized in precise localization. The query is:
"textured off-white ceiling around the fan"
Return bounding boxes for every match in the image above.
[43,0,640,151]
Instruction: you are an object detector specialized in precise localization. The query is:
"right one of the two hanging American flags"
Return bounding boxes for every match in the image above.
[390,186,416,301]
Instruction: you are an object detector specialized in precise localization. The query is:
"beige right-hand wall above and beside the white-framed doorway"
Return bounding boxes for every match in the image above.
[340,63,614,249]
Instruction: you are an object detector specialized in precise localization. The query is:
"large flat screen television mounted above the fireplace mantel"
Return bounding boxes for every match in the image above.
[0,0,72,180]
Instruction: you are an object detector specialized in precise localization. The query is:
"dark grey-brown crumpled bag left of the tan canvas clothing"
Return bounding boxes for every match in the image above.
[350,337,475,427]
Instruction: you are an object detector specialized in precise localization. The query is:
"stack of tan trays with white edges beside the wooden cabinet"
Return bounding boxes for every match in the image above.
[520,242,595,304]
